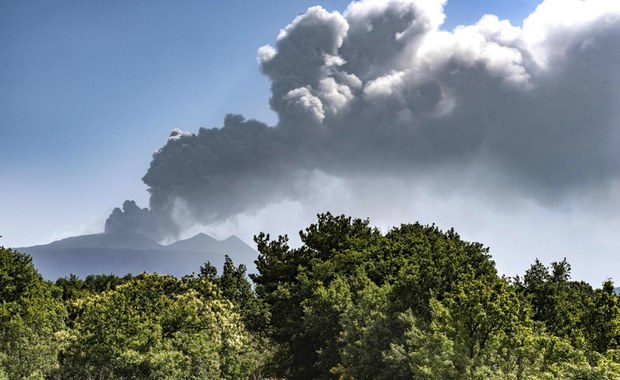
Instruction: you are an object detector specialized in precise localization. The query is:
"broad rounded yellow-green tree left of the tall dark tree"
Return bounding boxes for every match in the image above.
[57,274,256,379]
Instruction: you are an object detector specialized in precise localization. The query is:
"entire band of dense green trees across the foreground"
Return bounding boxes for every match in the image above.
[0,214,620,379]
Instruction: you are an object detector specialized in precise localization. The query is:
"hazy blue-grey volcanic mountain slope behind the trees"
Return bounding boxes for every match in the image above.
[16,233,257,280]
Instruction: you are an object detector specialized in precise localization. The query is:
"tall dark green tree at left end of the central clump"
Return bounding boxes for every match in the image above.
[252,213,380,379]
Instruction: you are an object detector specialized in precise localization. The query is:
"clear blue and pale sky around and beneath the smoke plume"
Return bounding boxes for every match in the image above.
[0,0,620,283]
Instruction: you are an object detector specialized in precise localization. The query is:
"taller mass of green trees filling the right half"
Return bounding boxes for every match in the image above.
[253,213,620,379]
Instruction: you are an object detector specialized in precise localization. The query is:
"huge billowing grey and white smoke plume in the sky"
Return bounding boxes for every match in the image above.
[110,0,620,240]
